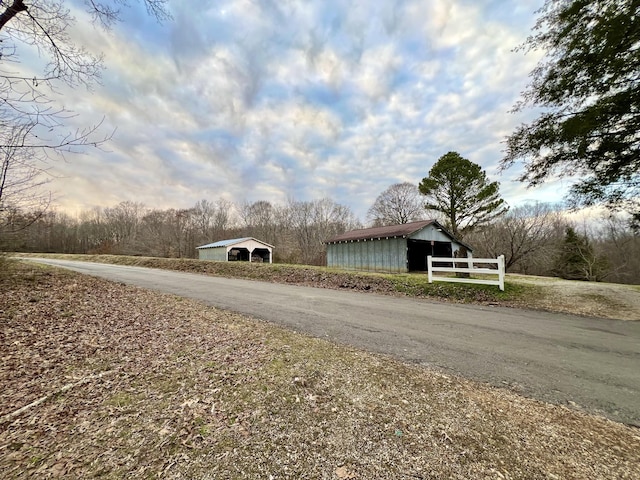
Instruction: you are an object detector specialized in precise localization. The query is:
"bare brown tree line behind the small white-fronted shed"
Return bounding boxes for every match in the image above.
[0,198,361,265]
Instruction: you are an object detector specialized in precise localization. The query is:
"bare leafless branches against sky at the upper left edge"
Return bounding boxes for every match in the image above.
[0,0,169,220]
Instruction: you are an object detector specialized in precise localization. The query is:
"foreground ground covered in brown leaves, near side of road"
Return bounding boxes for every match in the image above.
[0,262,640,479]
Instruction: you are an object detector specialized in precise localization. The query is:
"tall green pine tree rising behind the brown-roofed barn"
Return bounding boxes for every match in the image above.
[419,152,508,239]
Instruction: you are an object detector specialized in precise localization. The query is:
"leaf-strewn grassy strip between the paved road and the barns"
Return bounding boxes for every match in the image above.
[19,253,640,320]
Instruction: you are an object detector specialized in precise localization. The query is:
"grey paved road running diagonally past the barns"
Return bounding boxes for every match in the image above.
[22,259,640,426]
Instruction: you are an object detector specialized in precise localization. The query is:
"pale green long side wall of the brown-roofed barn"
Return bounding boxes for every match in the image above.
[327,238,407,273]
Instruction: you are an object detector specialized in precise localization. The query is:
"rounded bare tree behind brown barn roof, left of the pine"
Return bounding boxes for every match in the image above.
[367,182,426,226]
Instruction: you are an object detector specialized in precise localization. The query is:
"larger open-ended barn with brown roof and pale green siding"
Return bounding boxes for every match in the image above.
[325,220,472,273]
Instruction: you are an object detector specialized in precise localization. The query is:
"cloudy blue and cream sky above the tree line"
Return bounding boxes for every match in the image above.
[35,0,568,220]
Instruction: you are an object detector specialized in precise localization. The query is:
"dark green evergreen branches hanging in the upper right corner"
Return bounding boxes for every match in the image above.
[502,0,640,216]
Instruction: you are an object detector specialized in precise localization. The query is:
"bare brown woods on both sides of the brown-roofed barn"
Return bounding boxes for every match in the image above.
[5,198,640,284]
